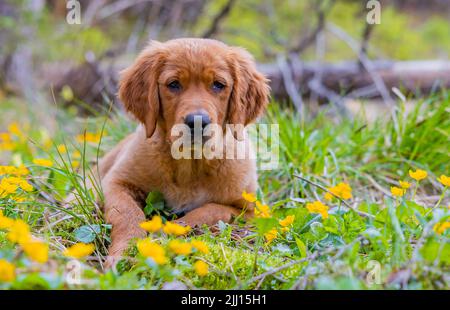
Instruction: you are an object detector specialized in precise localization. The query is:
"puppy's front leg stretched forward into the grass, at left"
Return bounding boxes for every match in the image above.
[104,183,146,267]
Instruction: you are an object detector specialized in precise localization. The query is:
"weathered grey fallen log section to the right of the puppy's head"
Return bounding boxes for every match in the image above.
[259,60,450,99]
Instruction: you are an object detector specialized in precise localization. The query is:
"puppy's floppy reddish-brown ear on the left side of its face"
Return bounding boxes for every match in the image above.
[119,41,165,138]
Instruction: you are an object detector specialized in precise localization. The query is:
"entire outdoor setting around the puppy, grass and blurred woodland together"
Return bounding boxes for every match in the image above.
[0,0,450,290]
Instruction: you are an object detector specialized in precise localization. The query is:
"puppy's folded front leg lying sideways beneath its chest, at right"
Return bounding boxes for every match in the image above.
[177,203,251,227]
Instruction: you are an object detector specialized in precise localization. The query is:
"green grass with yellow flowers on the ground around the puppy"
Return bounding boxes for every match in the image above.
[0,93,450,289]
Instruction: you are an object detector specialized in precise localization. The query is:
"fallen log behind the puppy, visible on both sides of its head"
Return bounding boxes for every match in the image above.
[46,58,450,111]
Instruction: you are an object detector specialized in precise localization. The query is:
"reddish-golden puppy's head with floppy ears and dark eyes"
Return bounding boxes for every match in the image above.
[119,39,269,138]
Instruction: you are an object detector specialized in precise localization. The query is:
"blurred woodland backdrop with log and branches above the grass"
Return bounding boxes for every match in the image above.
[0,0,450,129]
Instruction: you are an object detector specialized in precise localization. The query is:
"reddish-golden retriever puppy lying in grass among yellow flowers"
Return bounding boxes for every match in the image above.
[99,39,270,260]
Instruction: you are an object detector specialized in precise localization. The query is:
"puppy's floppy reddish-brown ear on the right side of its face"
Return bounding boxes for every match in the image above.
[227,47,270,140]
